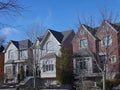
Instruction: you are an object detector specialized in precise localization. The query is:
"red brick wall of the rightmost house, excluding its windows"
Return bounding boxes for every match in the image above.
[97,22,119,72]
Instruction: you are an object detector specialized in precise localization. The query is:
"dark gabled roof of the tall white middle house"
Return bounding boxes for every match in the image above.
[49,29,74,43]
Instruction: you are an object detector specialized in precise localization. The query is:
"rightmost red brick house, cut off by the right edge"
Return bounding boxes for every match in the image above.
[96,21,120,79]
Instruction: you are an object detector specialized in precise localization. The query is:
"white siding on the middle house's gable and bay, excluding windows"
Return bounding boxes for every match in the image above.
[40,33,61,78]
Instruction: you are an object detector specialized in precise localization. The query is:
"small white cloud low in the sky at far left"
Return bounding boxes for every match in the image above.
[0,27,18,36]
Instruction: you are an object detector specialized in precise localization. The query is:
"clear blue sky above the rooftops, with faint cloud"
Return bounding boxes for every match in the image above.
[0,0,120,41]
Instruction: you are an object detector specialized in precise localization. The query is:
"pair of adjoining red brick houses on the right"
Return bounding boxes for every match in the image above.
[72,21,120,85]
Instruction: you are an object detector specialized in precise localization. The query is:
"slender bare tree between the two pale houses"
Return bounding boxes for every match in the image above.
[26,22,46,88]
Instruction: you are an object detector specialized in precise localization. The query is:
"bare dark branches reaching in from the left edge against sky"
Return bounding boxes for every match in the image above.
[0,0,25,45]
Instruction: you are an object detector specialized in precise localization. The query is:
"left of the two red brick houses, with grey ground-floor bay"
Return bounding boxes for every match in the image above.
[73,25,101,87]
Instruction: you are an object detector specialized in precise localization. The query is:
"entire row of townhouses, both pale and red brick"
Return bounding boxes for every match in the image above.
[0,21,120,87]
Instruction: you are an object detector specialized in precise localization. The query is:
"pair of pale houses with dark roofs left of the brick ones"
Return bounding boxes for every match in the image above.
[4,29,75,85]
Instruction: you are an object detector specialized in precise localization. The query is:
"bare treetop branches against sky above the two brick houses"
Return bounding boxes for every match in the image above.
[75,7,120,29]
